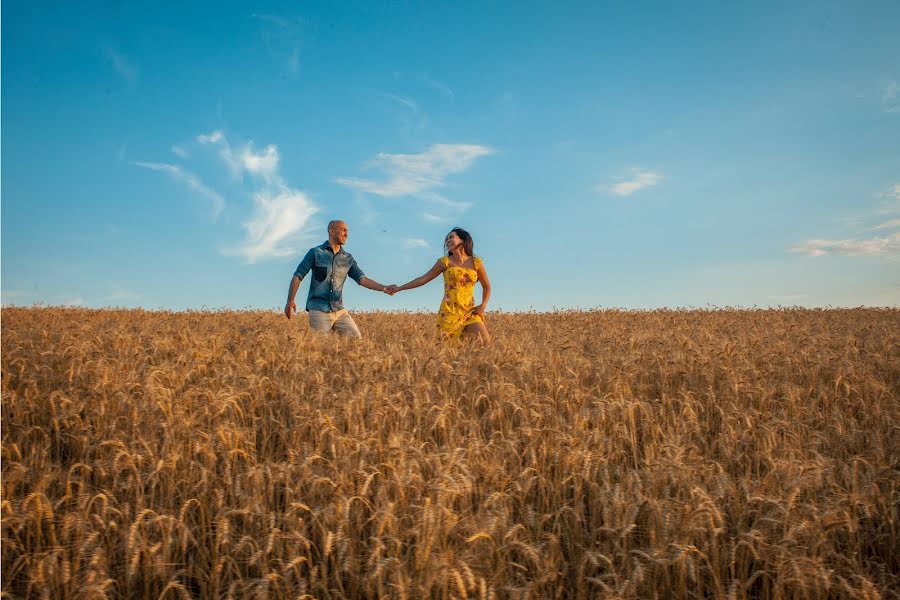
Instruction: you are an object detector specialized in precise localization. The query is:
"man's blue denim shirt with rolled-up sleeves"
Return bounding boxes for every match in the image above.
[294,241,365,312]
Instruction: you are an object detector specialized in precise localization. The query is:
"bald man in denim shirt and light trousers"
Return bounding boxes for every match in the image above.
[284,221,387,338]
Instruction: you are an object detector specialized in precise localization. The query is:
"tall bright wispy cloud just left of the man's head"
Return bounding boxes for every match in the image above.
[197,131,318,263]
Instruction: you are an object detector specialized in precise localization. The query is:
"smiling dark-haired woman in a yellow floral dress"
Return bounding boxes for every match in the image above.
[388,227,491,344]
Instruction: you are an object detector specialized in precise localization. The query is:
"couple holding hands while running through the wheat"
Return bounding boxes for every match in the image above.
[284,221,491,344]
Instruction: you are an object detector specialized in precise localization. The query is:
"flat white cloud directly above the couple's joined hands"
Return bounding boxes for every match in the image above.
[337,144,494,199]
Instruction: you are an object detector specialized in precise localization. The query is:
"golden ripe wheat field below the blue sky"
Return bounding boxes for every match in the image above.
[2,307,900,599]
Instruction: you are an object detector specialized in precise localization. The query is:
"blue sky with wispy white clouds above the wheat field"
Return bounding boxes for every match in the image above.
[0,0,900,311]
